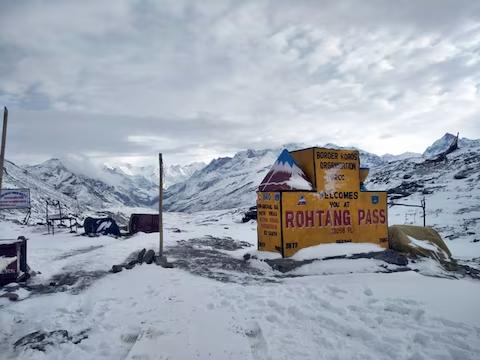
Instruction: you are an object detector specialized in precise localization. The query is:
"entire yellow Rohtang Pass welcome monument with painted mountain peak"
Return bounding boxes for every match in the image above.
[257,148,388,257]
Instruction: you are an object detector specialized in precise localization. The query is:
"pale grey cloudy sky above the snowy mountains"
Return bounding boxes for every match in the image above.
[0,0,480,163]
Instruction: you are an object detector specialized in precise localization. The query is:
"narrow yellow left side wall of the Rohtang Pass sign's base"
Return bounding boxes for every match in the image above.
[257,192,282,253]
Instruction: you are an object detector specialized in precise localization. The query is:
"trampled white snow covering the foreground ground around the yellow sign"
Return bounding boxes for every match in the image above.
[0,211,480,360]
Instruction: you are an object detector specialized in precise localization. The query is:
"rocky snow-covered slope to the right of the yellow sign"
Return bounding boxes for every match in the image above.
[366,137,480,245]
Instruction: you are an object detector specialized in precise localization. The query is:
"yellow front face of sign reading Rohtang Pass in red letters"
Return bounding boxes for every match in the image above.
[282,191,388,257]
